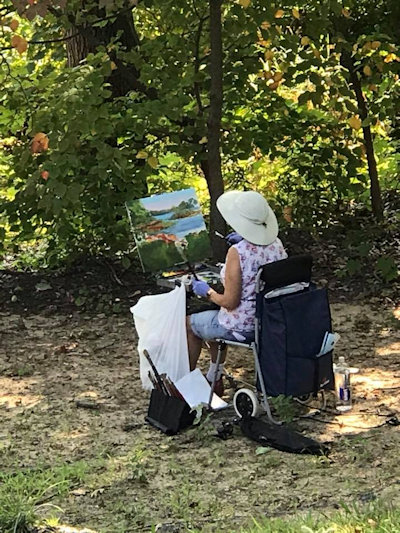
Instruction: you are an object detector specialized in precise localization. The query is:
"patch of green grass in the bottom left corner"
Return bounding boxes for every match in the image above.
[0,461,87,533]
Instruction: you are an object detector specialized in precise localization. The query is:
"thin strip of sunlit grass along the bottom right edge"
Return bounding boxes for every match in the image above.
[241,502,400,533]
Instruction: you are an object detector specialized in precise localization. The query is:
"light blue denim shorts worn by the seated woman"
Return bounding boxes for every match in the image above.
[190,310,254,342]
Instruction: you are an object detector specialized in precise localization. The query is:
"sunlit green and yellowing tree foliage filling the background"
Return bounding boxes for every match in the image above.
[0,0,400,266]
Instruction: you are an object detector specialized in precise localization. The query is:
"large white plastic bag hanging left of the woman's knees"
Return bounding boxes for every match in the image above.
[131,283,190,389]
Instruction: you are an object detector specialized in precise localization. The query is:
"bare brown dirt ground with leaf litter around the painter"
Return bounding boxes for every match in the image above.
[0,294,400,533]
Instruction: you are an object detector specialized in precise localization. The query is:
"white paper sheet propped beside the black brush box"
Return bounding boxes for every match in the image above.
[175,368,228,409]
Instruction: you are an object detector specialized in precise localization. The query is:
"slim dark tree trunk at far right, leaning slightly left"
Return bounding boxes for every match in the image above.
[347,58,383,220]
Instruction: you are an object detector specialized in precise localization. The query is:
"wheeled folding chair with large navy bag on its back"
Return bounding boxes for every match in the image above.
[210,255,334,423]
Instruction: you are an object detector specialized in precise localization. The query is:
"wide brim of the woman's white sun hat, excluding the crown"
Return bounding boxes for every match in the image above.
[217,191,279,245]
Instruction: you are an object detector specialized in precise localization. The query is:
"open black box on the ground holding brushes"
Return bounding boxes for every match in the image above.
[146,389,196,435]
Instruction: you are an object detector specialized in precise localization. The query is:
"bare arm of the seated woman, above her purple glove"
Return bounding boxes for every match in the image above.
[208,247,242,311]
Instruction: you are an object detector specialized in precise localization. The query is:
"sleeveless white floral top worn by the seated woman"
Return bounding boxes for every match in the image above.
[218,239,287,332]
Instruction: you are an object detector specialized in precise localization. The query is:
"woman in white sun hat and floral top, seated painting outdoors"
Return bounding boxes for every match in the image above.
[187,191,287,395]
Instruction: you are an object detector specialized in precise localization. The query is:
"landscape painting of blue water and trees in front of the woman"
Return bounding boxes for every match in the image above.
[127,189,211,271]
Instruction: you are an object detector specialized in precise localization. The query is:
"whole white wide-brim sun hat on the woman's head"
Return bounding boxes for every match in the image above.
[217,191,279,245]
